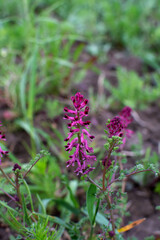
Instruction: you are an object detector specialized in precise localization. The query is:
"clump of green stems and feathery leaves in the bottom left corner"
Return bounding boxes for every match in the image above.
[0,150,66,240]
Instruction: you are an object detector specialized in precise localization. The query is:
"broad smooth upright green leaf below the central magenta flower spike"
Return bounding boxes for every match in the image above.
[86,183,97,224]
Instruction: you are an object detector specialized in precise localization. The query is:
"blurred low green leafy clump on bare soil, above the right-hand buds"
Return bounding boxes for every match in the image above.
[104,68,159,109]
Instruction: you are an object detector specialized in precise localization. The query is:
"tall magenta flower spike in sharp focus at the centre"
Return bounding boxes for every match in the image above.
[64,92,96,175]
